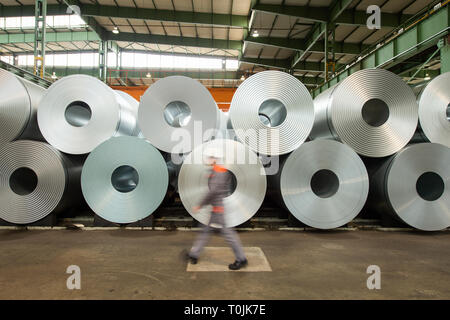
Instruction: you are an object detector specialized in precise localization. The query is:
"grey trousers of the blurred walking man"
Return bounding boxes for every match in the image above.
[189,213,246,261]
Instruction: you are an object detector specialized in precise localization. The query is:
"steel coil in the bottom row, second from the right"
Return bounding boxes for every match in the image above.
[278,140,369,229]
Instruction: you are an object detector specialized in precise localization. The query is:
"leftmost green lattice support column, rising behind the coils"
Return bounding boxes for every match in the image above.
[34,0,47,78]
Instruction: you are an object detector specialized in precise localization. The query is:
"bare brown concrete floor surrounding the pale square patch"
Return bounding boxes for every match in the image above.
[0,230,450,299]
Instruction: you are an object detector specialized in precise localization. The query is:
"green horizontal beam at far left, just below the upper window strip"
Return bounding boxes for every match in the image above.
[0,31,100,44]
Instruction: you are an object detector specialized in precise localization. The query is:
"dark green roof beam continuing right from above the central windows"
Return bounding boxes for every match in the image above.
[245,37,369,55]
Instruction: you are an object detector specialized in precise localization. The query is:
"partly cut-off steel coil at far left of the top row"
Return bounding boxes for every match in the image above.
[0,69,45,144]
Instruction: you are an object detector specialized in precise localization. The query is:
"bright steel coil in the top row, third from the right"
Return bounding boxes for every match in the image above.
[229,71,314,155]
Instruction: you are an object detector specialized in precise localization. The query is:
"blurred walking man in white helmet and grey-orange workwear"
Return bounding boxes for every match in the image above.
[188,149,248,270]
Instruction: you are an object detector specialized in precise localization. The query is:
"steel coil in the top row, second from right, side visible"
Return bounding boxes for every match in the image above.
[311,69,418,157]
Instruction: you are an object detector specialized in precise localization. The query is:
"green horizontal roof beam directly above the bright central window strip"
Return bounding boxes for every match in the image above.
[107,32,242,51]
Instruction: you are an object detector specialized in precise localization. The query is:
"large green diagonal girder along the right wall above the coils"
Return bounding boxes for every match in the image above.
[313,5,450,96]
